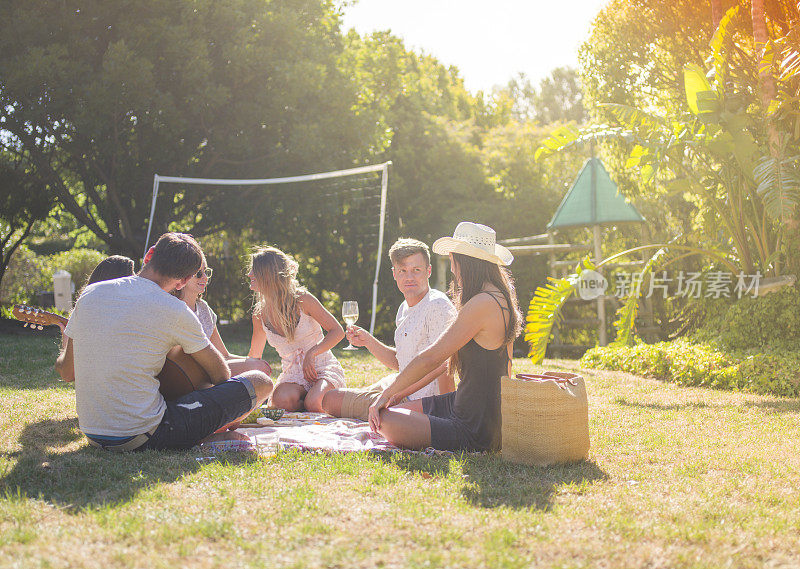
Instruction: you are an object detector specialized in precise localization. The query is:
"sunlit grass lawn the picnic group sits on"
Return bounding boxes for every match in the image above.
[0,330,800,569]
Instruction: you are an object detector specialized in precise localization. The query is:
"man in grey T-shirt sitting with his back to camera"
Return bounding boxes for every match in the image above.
[56,233,272,451]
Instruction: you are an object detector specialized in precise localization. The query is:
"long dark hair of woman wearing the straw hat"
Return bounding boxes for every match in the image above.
[448,253,522,373]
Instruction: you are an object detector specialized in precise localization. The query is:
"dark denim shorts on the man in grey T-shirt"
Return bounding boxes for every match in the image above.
[136,376,258,450]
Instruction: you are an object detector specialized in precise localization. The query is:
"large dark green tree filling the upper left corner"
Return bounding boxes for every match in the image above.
[0,0,372,257]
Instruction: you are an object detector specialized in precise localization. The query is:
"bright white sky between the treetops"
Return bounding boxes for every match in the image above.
[344,0,608,91]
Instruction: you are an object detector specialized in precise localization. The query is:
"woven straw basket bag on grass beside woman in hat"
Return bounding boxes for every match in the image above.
[500,371,589,465]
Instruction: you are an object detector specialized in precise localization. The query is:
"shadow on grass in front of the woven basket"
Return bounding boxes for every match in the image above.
[384,453,609,511]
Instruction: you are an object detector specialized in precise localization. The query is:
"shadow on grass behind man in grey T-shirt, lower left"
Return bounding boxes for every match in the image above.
[0,418,255,513]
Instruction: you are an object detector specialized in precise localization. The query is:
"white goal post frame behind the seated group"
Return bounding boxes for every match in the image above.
[142,161,391,334]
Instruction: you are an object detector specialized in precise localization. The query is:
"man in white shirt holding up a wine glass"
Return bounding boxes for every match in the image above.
[322,239,456,421]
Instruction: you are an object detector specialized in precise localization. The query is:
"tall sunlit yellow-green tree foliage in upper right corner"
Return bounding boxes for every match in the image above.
[582,0,798,274]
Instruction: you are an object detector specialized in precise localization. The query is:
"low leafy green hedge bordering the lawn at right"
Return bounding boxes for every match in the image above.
[581,339,800,397]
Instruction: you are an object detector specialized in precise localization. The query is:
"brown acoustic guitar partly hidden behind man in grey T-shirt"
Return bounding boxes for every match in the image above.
[11,304,213,401]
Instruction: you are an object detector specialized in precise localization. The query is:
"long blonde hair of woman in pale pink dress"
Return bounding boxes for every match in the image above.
[250,247,306,340]
